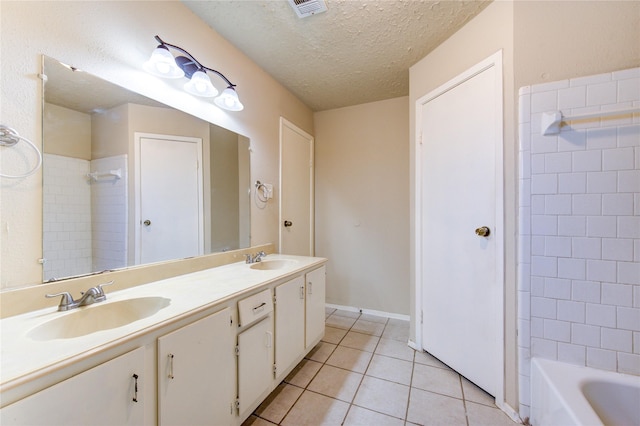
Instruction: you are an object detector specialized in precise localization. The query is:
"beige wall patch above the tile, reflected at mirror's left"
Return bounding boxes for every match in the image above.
[42,104,91,160]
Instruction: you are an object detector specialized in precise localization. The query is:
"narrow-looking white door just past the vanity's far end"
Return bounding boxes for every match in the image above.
[280,118,314,256]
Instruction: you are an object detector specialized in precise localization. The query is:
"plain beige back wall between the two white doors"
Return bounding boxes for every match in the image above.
[315,97,409,315]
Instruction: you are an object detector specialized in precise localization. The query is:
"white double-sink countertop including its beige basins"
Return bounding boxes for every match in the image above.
[0,254,327,391]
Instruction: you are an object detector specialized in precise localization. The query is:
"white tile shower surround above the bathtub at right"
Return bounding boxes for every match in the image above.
[518,68,640,418]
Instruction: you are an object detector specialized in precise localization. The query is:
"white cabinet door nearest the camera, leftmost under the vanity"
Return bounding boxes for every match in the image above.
[0,348,146,425]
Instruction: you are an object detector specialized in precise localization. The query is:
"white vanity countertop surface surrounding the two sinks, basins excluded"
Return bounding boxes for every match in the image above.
[0,254,326,390]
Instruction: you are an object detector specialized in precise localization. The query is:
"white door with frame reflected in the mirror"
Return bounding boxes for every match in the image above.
[135,133,204,263]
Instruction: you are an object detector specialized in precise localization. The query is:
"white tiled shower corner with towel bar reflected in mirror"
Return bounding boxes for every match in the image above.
[43,154,128,280]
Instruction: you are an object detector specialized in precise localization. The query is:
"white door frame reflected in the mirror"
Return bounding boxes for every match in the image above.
[133,132,204,265]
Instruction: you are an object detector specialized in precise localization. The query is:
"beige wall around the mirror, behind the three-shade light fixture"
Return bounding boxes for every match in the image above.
[0,1,314,289]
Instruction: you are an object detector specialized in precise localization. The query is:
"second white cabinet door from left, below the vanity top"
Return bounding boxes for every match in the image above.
[158,308,235,425]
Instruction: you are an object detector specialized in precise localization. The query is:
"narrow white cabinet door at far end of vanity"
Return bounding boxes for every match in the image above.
[305,266,326,350]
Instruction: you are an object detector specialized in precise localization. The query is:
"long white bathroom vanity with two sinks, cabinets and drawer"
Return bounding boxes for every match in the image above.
[0,255,327,425]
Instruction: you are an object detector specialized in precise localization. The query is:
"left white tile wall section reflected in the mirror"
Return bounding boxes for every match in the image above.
[42,154,91,281]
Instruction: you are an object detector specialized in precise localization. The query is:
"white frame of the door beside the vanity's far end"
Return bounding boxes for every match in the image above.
[278,117,315,256]
